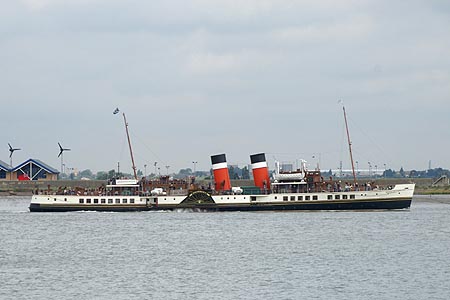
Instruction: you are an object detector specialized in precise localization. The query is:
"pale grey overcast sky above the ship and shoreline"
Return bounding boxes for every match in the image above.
[0,0,450,173]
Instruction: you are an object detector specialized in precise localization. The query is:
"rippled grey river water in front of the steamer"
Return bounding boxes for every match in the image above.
[0,196,450,300]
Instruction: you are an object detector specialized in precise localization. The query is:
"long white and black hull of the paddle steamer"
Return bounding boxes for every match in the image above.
[30,184,414,211]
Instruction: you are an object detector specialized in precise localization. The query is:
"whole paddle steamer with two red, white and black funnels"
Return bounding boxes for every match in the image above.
[30,108,415,212]
